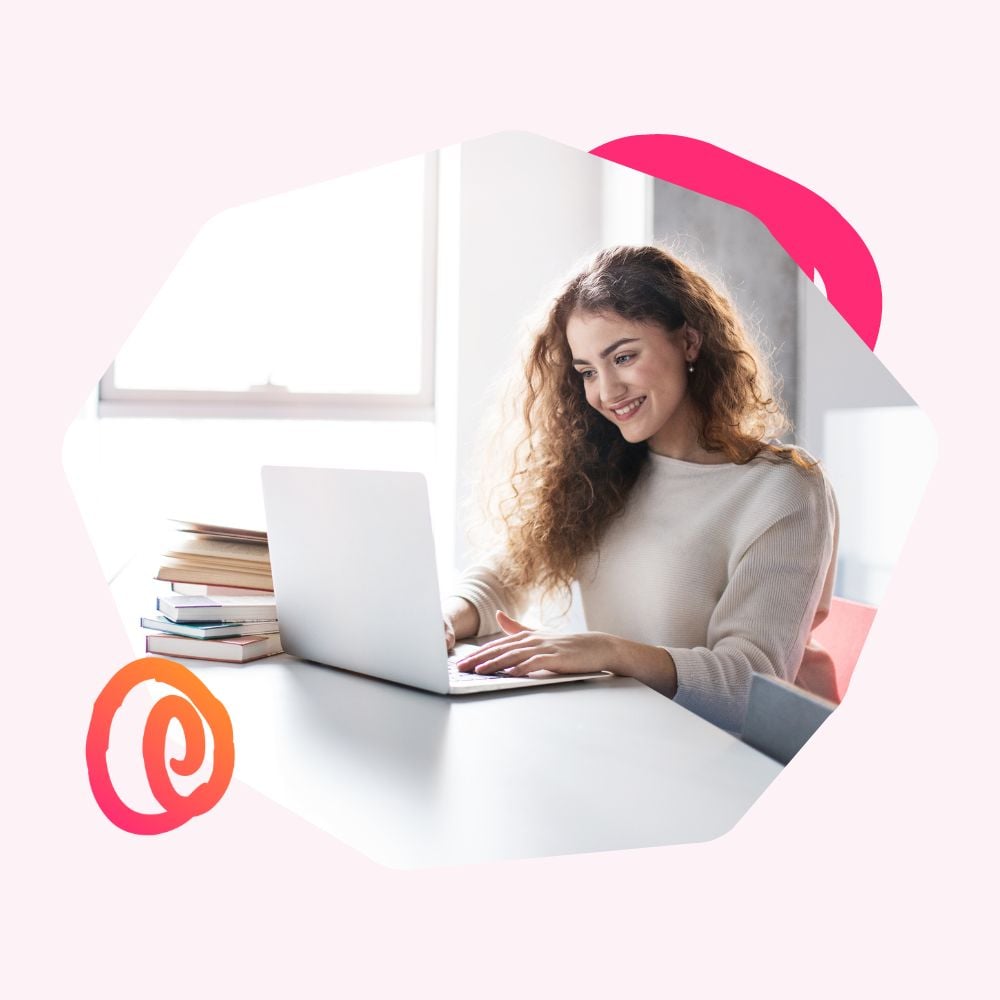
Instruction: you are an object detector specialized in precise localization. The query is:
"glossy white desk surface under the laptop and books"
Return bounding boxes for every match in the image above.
[114,568,781,868]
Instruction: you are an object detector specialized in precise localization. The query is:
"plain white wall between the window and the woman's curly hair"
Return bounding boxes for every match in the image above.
[436,133,602,584]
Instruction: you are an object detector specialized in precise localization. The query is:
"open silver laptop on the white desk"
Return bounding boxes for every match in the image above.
[261,466,607,694]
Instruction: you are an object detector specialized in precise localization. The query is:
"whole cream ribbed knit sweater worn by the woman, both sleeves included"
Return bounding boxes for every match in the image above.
[455,453,839,731]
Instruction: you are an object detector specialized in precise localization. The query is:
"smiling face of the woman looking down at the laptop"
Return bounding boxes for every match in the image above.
[566,312,703,460]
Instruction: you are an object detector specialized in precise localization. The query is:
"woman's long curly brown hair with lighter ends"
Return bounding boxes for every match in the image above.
[482,246,811,594]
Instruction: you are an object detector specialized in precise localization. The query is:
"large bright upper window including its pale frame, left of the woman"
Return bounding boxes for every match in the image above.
[99,154,437,420]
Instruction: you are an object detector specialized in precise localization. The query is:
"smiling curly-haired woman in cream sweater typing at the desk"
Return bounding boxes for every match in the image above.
[444,246,837,730]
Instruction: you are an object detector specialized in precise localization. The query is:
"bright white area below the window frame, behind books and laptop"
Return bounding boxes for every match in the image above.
[63,402,434,579]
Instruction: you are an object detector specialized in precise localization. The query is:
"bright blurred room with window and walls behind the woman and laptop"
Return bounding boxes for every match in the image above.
[64,133,935,604]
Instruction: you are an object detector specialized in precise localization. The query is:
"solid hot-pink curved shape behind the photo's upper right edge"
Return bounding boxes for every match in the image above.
[591,135,882,349]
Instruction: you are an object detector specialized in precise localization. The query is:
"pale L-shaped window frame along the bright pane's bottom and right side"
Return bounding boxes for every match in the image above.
[97,151,439,421]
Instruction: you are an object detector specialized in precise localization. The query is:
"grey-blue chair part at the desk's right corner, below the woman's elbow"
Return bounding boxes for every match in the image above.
[740,674,837,764]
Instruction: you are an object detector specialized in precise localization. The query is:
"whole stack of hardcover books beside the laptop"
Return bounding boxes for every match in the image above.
[140,521,281,663]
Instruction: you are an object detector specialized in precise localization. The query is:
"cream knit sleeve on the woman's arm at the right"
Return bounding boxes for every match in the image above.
[664,472,838,732]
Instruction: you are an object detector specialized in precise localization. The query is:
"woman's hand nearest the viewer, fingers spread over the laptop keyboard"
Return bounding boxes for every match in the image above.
[458,611,616,677]
